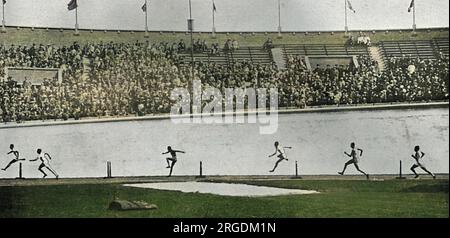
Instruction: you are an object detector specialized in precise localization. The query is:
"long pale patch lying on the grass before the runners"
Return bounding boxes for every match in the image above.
[124,182,319,197]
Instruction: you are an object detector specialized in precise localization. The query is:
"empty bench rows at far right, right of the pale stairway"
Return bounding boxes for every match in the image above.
[379,38,449,59]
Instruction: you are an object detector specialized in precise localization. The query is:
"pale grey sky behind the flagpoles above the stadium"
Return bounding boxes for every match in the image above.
[0,0,449,32]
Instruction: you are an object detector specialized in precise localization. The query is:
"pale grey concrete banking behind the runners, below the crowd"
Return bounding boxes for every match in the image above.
[0,105,449,178]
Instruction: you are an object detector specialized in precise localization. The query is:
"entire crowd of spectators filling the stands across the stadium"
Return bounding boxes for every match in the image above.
[0,40,449,122]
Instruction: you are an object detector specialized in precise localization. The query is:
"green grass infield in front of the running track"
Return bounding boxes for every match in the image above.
[0,179,449,218]
